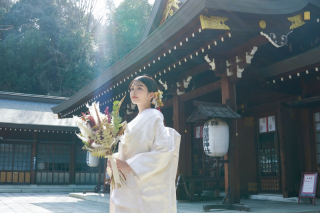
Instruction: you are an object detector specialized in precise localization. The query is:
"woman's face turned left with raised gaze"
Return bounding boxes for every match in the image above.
[130,80,154,105]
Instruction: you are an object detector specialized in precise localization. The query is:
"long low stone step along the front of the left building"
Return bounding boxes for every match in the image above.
[0,184,95,193]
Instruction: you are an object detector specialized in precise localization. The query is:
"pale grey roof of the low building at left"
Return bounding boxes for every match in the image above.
[0,91,77,131]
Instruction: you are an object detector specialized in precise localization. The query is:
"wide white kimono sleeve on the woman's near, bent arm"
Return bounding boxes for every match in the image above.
[126,117,174,180]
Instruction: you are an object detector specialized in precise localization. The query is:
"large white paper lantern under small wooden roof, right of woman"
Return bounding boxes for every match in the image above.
[203,118,229,157]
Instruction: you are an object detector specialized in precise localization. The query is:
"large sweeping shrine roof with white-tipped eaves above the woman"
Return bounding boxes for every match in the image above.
[52,0,320,117]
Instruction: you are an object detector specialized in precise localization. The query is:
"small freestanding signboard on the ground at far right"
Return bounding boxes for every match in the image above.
[298,172,318,205]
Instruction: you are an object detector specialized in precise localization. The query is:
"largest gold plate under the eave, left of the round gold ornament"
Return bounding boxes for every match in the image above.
[200,15,230,30]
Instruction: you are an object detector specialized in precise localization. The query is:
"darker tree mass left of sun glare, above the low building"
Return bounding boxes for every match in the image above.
[0,0,100,96]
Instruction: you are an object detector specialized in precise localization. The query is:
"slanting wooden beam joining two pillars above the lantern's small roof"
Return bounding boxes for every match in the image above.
[179,80,221,101]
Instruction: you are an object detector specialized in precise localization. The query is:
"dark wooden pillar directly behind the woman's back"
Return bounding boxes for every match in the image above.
[173,95,186,174]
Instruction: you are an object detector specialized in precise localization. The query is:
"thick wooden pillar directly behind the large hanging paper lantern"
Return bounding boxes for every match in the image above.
[221,76,240,204]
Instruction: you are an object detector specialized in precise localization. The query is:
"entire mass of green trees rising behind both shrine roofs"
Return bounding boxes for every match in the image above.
[0,0,151,97]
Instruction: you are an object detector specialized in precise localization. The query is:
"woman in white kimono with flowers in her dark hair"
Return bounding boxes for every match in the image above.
[108,76,181,213]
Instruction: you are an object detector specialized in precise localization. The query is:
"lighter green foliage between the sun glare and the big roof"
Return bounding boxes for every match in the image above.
[96,0,152,67]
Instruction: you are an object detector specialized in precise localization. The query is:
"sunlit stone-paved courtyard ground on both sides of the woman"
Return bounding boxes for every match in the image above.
[0,193,320,213]
